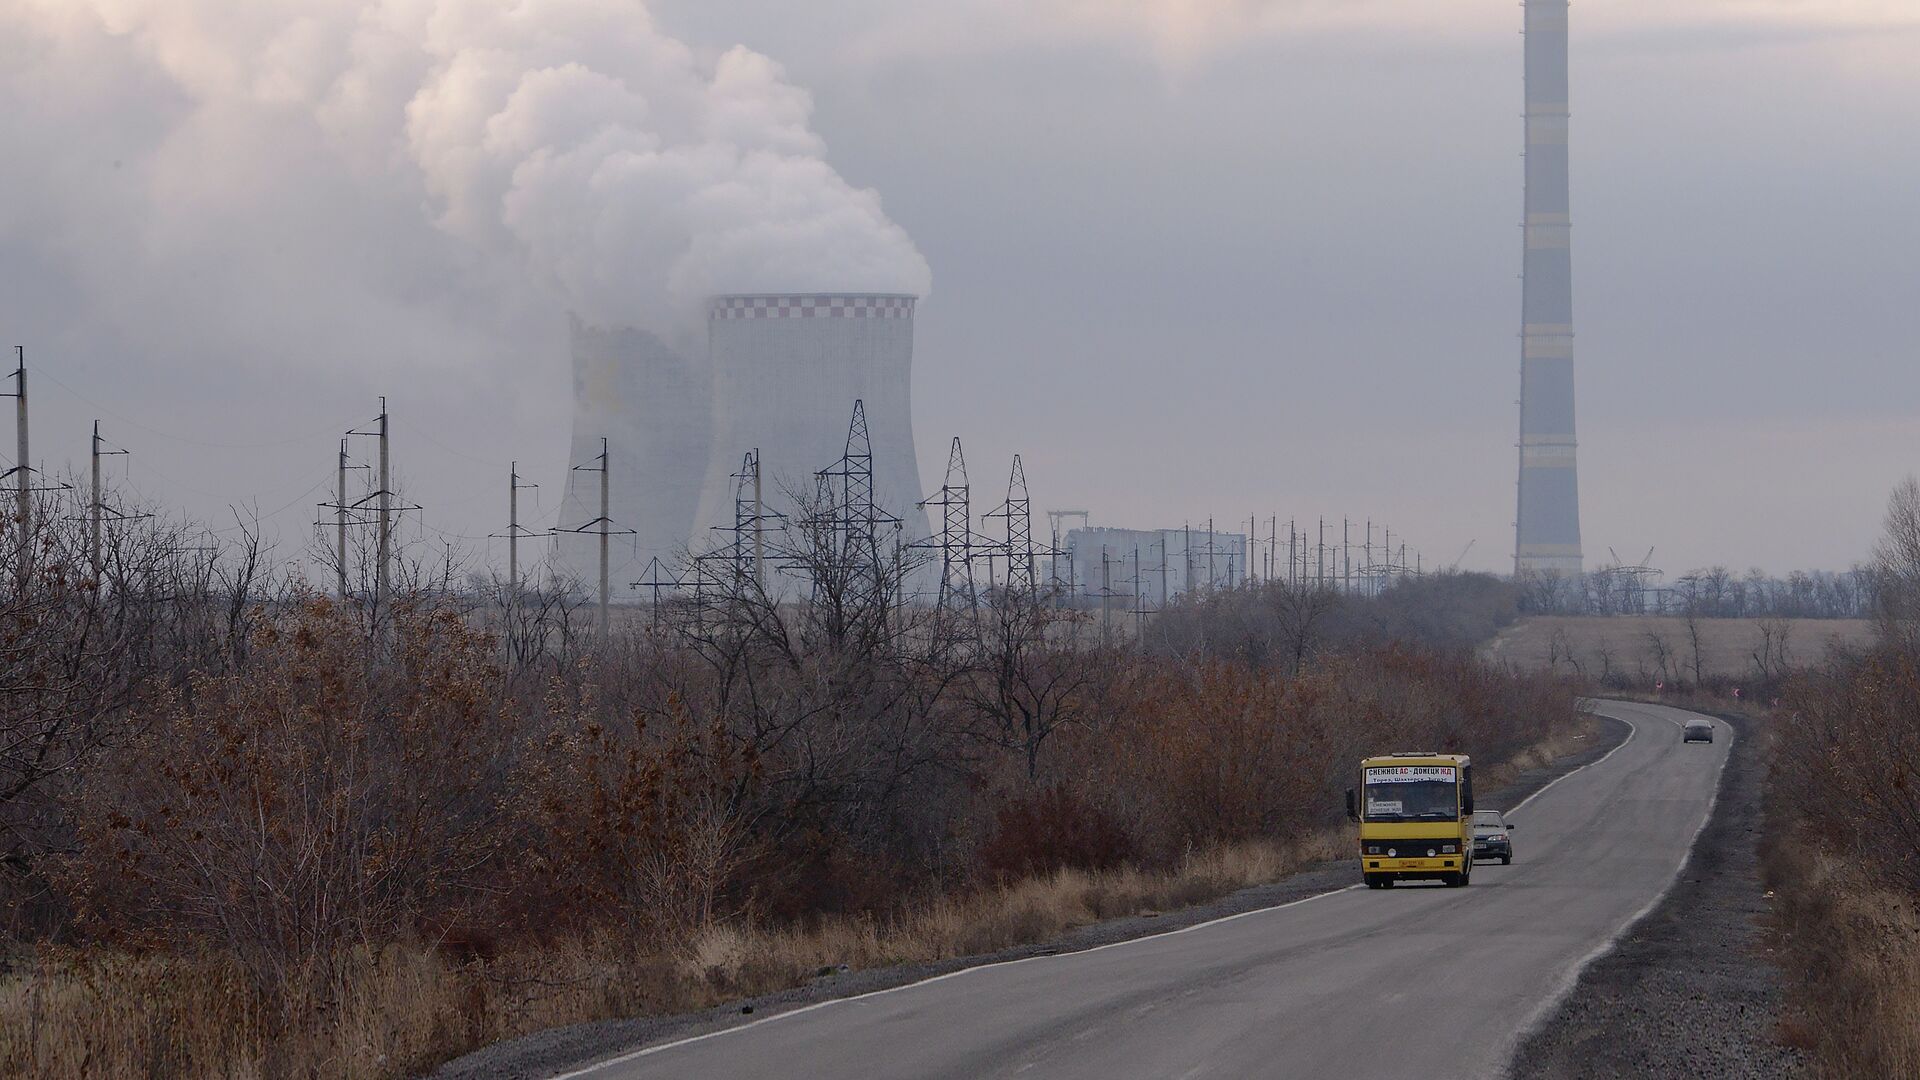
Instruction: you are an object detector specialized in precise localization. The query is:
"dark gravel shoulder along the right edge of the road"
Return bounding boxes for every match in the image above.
[1507,717,1809,1080]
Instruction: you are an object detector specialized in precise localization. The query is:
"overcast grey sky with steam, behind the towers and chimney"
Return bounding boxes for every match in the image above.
[0,0,1920,573]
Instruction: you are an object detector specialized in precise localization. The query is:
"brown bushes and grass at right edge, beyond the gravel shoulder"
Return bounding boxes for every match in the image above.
[1764,480,1920,1076]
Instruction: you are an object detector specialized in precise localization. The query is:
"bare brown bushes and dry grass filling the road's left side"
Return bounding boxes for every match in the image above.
[0,496,1580,1076]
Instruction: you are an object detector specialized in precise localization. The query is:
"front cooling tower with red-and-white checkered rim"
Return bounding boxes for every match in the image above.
[693,294,927,548]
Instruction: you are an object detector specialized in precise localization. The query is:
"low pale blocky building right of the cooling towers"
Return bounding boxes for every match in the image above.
[1054,527,1248,609]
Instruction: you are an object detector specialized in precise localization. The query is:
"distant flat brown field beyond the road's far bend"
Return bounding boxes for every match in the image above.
[1484,615,1872,682]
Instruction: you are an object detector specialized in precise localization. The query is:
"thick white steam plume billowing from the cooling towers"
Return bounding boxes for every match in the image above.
[0,0,929,332]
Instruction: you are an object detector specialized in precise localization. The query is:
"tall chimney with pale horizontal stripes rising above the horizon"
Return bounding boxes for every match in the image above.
[1513,0,1580,577]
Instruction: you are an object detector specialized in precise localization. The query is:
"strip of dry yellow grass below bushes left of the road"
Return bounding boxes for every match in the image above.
[0,830,1344,1080]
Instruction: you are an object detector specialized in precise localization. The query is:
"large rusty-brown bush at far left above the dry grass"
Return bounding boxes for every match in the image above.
[60,600,507,990]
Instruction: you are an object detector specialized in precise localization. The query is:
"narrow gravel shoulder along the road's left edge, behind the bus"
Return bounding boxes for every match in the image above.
[432,717,1632,1080]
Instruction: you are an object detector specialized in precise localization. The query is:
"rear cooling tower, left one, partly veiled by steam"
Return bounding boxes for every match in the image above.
[555,319,712,584]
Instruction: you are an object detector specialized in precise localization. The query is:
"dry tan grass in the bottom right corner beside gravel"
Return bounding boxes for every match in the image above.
[1766,840,1920,1078]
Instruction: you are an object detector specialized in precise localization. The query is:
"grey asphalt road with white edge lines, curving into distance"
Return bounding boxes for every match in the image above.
[552,701,1734,1080]
